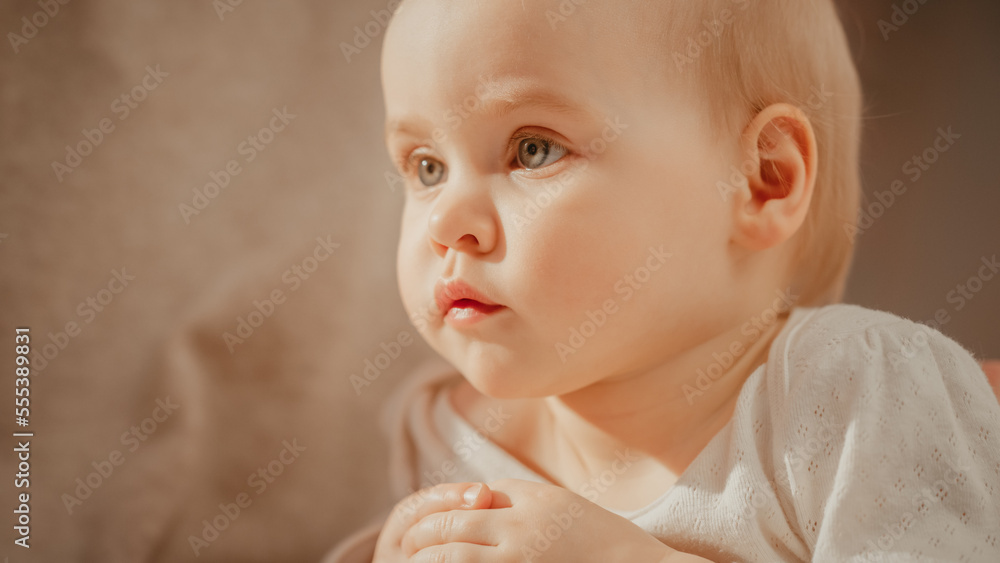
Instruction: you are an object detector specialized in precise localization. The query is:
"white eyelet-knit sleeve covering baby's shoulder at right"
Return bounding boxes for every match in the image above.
[752,305,1000,560]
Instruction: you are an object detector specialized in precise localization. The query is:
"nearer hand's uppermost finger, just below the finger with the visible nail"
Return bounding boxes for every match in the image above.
[402,510,501,557]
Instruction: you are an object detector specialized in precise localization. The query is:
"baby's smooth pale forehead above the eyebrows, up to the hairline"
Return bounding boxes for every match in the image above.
[382,0,676,118]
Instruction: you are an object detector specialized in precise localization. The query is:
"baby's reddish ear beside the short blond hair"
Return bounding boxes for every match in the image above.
[732,104,817,250]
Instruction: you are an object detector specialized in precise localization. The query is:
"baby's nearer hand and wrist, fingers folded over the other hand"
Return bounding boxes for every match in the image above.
[401,479,707,563]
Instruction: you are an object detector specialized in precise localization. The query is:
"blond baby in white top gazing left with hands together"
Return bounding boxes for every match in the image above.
[340,0,1000,563]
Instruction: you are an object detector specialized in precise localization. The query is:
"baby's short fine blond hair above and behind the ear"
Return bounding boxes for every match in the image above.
[661,0,863,306]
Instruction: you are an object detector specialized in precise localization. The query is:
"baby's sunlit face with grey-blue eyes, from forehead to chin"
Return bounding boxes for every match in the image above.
[382,0,738,397]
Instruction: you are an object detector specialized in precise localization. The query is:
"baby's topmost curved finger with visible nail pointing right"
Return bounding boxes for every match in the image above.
[382,483,492,545]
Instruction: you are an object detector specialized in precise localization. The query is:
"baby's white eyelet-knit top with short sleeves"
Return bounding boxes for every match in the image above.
[327,305,1000,563]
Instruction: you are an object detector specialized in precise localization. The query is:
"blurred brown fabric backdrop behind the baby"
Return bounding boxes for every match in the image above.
[0,0,1000,562]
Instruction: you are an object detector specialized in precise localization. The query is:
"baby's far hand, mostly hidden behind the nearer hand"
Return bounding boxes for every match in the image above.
[373,483,492,563]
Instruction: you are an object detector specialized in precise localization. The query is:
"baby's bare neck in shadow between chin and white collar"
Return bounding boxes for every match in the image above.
[545,315,787,476]
